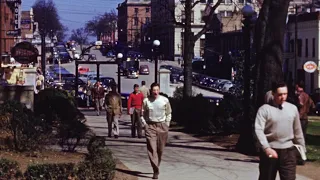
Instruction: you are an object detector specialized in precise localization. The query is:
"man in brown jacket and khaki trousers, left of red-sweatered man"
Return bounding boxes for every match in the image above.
[104,84,122,139]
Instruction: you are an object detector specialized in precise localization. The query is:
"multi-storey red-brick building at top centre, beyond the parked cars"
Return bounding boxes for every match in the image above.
[117,0,151,48]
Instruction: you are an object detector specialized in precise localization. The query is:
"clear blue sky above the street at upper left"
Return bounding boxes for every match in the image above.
[22,0,124,39]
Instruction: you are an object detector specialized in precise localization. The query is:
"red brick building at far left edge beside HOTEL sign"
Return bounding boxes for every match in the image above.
[0,0,15,54]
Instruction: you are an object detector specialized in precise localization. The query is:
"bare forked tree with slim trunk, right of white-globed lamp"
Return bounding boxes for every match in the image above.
[161,0,222,97]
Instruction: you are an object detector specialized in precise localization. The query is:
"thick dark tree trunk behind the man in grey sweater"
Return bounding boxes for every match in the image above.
[237,0,290,153]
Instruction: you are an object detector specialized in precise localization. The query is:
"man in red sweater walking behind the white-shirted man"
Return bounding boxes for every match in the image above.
[127,84,144,138]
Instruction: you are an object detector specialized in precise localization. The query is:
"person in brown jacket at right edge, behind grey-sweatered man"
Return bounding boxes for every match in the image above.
[295,82,316,139]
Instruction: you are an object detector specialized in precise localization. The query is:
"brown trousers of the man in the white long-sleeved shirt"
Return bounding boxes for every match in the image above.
[145,123,169,173]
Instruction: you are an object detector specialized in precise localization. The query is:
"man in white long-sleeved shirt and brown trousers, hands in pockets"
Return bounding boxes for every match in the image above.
[141,83,171,179]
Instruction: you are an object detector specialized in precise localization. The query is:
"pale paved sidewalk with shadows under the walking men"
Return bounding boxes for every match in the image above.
[83,110,308,180]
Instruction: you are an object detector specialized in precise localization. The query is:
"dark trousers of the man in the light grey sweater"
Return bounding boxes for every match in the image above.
[259,147,297,180]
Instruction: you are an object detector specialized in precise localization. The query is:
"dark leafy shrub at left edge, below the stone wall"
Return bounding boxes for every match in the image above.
[0,101,51,151]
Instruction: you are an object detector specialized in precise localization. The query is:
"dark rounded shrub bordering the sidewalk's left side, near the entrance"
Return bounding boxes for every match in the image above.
[35,89,89,151]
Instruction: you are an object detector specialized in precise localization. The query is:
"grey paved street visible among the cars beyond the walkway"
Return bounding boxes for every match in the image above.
[62,49,223,97]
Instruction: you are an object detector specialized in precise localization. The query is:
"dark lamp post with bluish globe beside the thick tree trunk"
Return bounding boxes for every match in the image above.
[242,5,255,124]
